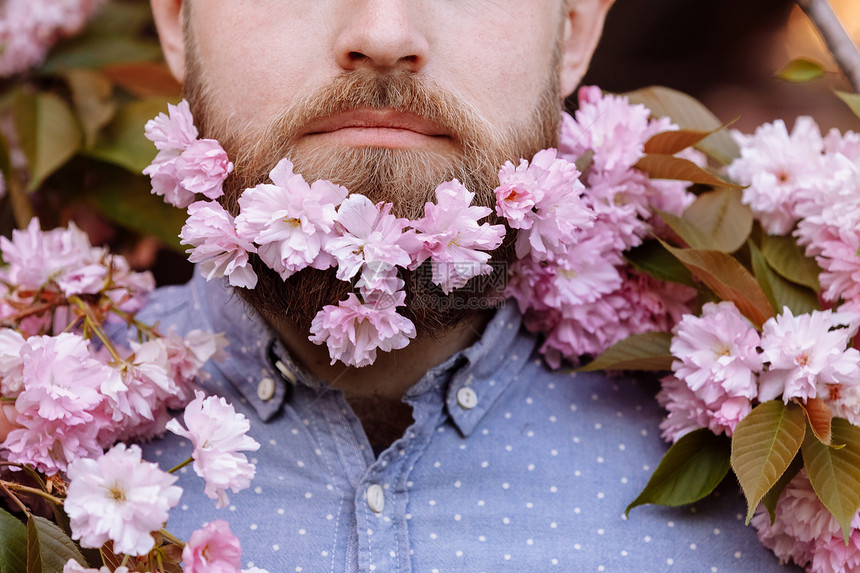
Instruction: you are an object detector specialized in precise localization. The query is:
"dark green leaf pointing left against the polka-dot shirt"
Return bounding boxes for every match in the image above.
[624,428,731,515]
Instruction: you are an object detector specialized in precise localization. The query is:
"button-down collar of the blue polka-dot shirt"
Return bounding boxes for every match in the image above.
[193,276,534,428]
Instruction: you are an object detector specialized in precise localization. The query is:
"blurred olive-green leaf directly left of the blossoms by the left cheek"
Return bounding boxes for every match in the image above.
[89,97,175,174]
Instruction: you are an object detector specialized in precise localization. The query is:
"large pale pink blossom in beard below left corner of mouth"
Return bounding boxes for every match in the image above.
[236,159,348,279]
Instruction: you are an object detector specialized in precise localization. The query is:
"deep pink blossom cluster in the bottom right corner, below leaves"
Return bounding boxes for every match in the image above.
[752,470,860,573]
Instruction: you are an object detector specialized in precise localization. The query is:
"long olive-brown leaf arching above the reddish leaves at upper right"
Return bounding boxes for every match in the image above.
[622,86,741,165]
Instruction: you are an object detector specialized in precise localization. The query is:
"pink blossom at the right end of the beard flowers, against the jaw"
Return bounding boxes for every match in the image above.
[495,149,595,260]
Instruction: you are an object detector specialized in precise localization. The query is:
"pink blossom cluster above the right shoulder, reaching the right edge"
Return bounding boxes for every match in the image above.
[657,302,860,442]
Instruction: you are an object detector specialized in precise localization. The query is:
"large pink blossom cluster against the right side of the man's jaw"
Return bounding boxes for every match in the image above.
[508,87,700,365]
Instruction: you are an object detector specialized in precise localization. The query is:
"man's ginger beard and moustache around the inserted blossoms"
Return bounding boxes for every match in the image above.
[185,52,561,337]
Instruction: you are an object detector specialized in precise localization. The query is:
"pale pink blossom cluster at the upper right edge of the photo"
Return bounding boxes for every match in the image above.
[728,117,860,310]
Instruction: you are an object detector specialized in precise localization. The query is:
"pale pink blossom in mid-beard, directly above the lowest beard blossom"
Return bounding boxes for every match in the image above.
[325,194,420,294]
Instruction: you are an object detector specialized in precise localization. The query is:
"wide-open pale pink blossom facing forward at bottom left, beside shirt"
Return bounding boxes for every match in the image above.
[64,444,182,555]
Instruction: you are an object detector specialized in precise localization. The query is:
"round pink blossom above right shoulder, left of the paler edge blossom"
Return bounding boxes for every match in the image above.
[671,302,762,404]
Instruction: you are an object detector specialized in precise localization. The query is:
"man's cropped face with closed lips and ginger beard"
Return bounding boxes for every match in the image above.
[160,0,602,331]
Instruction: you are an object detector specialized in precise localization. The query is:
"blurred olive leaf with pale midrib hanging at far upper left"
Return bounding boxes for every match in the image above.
[13,91,83,191]
